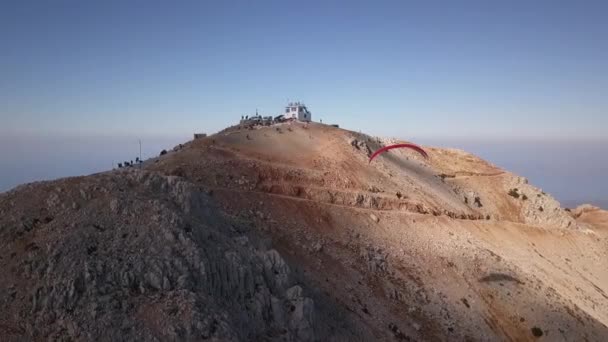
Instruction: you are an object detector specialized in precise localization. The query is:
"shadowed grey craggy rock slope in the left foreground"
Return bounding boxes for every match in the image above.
[0,170,370,341]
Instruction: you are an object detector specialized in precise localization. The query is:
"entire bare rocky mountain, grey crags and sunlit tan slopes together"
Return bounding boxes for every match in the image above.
[0,124,608,341]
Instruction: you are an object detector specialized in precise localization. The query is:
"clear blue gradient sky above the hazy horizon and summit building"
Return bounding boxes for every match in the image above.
[0,1,608,140]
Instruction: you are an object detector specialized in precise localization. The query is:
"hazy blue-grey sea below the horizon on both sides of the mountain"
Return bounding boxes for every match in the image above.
[0,136,608,209]
